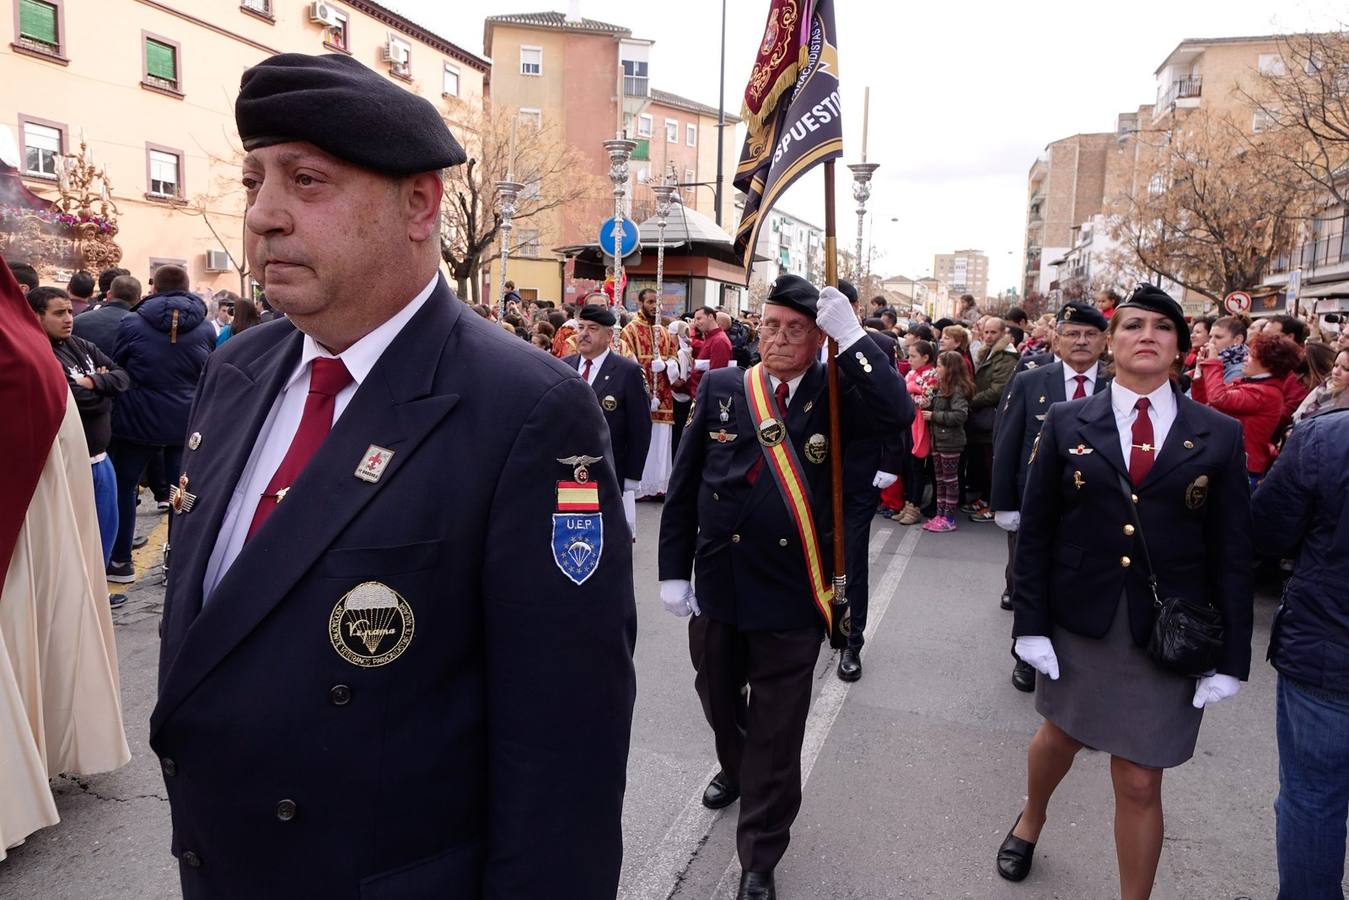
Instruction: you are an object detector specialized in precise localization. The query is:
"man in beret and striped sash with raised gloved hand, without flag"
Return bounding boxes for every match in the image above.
[660,275,913,900]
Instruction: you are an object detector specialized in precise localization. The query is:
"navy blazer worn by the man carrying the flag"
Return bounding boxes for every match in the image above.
[660,340,913,630]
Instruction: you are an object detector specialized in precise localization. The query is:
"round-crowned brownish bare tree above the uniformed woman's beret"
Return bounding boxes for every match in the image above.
[1110,111,1306,302]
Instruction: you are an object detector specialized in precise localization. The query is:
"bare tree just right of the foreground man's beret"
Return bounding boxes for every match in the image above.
[440,109,603,304]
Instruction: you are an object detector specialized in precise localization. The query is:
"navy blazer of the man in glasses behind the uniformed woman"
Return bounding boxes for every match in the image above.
[989,362,1110,513]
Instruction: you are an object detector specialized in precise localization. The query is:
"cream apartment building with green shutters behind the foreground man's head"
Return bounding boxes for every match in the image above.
[0,0,488,294]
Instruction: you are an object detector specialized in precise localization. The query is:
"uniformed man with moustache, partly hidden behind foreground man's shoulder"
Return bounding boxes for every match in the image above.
[563,305,652,540]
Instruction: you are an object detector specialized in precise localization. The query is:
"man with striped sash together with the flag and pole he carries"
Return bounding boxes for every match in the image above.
[660,8,913,900]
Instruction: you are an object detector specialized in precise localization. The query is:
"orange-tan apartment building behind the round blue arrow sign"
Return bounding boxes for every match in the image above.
[483,5,739,302]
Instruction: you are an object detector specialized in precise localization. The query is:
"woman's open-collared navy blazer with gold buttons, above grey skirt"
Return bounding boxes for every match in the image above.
[1012,387,1253,679]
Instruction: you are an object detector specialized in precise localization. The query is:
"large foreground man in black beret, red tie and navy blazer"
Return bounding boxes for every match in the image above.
[150,54,635,900]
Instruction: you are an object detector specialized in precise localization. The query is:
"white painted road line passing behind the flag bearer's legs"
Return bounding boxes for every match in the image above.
[618,528,919,900]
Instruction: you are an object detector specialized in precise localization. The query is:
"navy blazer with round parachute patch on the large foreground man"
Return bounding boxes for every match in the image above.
[150,279,635,900]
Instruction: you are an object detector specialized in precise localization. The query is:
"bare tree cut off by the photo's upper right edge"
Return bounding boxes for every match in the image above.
[1238,31,1349,206]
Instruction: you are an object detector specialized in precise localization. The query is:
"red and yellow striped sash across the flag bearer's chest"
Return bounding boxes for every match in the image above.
[745,363,834,634]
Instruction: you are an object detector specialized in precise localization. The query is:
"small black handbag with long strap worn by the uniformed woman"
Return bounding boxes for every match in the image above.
[1120,475,1224,679]
